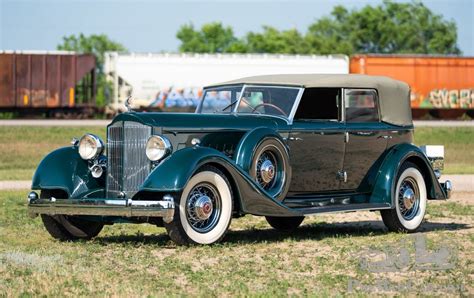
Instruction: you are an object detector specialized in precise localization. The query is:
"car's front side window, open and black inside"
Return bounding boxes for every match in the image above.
[294,88,341,121]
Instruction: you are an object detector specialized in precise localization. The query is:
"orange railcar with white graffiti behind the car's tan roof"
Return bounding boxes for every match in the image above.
[350,55,474,118]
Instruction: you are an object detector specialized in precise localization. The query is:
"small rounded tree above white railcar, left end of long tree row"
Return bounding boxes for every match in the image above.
[176,22,246,53]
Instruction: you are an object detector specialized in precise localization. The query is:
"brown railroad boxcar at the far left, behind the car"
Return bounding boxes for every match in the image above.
[0,51,96,115]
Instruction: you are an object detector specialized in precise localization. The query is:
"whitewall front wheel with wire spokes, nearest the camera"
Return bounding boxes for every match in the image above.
[164,166,233,245]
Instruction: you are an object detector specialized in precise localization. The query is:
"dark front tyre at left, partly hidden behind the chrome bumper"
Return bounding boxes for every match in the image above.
[40,190,104,241]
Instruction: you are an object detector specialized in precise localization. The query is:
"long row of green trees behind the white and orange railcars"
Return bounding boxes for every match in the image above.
[177,0,461,55]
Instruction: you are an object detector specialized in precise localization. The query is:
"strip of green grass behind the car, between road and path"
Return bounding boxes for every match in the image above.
[0,127,474,180]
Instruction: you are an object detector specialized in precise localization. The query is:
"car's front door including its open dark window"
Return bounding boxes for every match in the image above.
[288,88,344,194]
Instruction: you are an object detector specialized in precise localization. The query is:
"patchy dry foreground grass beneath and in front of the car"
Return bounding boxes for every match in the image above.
[0,190,474,297]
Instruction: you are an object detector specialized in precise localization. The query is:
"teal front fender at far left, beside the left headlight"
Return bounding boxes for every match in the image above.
[31,147,104,198]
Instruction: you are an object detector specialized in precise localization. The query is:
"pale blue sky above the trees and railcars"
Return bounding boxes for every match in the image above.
[0,0,474,56]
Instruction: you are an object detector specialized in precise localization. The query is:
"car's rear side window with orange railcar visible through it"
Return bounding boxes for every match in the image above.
[344,89,379,122]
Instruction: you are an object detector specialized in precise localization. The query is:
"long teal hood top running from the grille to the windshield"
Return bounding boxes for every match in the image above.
[111,112,288,131]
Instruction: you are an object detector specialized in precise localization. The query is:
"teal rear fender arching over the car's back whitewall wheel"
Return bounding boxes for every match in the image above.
[370,143,447,206]
